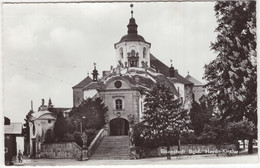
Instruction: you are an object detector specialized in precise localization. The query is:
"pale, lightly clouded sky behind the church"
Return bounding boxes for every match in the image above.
[2,2,217,122]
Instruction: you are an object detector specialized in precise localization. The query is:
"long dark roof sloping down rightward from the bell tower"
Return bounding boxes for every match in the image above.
[150,54,193,85]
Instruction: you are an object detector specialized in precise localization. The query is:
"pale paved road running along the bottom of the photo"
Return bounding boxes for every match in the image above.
[15,154,259,166]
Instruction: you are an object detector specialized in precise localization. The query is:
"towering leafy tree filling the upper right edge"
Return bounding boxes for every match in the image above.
[204,1,257,153]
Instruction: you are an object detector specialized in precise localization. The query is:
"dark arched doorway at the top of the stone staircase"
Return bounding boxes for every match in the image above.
[110,118,129,136]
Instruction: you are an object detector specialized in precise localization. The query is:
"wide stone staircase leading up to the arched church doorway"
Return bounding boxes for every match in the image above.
[90,136,130,160]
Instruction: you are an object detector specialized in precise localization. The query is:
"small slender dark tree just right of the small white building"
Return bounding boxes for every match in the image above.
[53,112,67,141]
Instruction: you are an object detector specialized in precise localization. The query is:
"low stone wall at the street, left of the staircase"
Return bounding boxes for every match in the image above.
[40,142,81,159]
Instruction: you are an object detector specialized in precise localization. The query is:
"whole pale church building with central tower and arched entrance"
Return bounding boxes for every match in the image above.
[73,5,197,135]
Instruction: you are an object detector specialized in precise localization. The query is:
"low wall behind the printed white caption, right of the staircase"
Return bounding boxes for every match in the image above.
[137,144,238,158]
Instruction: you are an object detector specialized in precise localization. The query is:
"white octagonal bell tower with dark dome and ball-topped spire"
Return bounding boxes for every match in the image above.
[114,4,151,67]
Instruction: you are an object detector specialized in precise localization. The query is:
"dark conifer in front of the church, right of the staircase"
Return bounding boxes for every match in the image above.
[134,83,190,159]
